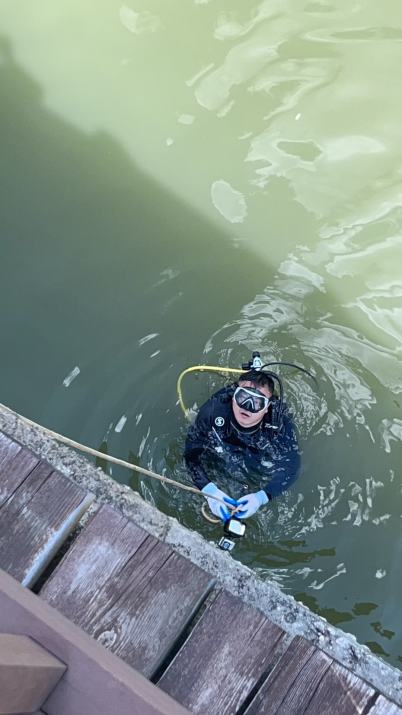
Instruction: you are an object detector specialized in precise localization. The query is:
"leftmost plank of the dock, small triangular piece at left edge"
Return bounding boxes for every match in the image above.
[0,432,39,507]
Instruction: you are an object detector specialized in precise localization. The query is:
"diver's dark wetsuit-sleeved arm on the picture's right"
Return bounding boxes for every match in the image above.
[262,414,300,499]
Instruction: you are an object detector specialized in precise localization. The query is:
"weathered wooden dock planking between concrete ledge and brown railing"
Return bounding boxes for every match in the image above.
[0,433,402,715]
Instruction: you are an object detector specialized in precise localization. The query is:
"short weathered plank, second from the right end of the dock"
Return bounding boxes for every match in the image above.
[305,663,376,715]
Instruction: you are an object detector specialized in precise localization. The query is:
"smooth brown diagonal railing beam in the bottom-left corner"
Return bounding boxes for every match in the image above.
[0,570,189,715]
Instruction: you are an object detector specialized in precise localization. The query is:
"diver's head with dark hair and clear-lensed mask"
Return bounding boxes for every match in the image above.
[232,370,275,427]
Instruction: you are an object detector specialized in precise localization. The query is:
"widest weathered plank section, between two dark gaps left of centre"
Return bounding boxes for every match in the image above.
[40,506,213,677]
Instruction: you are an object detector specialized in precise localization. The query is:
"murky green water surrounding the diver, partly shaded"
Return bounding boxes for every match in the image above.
[0,0,402,665]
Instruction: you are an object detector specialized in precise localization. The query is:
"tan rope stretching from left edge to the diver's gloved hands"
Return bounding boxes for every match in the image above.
[0,403,236,512]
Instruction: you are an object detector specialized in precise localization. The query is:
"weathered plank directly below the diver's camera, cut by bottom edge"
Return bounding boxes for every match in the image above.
[158,591,284,715]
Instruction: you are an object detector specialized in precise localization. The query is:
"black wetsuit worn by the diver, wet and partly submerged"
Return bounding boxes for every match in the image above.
[184,385,300,499]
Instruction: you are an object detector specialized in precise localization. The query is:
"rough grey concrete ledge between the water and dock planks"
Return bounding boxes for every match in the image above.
[0,408,402,706]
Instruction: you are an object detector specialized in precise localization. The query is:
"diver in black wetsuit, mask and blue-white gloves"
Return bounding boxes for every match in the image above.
[184,370,300,522]
